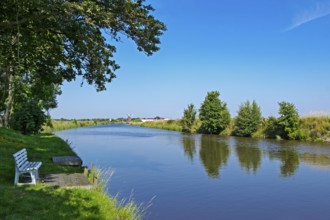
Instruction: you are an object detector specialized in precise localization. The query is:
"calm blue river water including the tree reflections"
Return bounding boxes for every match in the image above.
[56,125,330,220]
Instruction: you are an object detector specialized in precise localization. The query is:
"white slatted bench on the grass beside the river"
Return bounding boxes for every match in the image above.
[13,148,42,185]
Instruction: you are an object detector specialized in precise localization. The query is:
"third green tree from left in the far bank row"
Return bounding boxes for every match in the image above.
[234,101,261,137]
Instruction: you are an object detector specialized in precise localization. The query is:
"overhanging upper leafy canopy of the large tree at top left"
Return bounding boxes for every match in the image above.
[0,0,165,90]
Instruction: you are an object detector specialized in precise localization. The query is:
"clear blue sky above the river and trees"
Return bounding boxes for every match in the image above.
[51,0,330,119]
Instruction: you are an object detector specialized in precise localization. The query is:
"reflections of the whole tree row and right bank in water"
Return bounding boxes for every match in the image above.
[181,135,330,178]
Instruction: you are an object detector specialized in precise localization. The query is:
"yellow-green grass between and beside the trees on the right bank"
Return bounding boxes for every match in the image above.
[130,116,330,142]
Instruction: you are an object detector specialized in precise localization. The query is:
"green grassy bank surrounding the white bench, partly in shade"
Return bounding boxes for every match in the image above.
[0,128,140,219]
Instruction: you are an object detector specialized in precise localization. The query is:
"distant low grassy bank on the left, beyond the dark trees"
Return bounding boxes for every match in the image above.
[42,119,110,133]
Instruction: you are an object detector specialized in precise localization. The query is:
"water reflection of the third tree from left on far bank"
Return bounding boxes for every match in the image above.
[235,138,261,174]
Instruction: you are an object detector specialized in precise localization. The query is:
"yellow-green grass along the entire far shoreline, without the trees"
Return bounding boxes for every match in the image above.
[43,115,330,142]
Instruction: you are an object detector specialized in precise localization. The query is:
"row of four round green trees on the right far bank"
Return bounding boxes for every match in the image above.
[181,91,304,140]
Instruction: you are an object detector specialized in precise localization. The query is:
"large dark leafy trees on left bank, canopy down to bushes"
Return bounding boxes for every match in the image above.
[0,0,166,134]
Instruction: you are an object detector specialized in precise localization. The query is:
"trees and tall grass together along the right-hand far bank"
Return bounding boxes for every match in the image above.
[130,91,330,142]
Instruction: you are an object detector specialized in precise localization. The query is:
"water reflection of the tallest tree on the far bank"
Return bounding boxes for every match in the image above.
[199,135,229,178]
